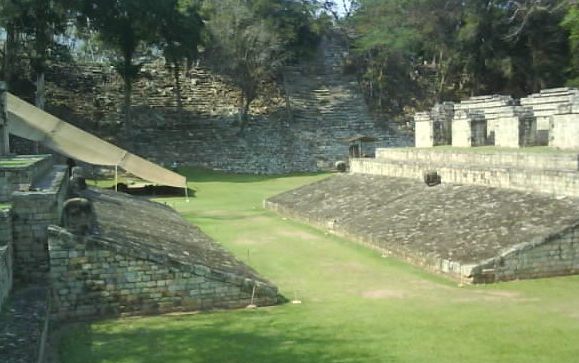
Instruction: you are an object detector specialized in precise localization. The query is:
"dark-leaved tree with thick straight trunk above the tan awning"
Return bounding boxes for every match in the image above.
[80,0,158,126]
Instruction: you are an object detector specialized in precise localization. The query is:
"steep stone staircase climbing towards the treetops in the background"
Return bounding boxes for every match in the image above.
[284,35,410,165]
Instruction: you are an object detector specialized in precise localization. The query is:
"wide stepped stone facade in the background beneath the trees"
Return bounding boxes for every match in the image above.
[38,37,411,174]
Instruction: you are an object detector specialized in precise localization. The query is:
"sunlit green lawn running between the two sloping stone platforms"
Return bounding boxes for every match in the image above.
[59,171,579,363]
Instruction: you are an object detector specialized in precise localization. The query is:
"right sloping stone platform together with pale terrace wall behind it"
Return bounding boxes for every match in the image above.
[265,144,579,283]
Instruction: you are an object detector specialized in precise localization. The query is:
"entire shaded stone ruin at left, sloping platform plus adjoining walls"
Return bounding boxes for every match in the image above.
[0,86,279,363]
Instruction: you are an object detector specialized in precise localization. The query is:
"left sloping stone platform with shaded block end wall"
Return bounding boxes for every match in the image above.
[48,189,278,319]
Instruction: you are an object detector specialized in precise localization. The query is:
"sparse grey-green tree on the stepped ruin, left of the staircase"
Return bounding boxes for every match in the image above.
[207,0,286,135]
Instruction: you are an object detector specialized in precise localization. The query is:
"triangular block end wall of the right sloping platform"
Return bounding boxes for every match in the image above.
[471,225,579,283]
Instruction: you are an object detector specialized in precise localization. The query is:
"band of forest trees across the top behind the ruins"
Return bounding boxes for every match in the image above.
[0,0,579,121]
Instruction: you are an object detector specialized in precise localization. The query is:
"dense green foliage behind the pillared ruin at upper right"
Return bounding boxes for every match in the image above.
[346,0,577,120]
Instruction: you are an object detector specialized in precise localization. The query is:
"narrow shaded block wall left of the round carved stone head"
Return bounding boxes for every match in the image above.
[12,166,68,282]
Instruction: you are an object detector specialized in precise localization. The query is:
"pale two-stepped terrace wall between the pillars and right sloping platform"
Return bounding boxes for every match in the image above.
[350,147,579,197]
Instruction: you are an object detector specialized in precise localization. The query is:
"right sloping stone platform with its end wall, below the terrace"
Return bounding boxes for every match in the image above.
[265,175,579,283]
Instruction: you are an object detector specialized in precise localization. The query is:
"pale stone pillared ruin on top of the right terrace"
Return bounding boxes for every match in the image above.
[414,88,579,149]
